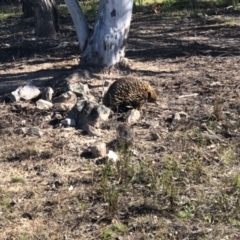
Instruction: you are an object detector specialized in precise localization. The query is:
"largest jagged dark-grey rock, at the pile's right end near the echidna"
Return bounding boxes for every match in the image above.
[68,100,111,128]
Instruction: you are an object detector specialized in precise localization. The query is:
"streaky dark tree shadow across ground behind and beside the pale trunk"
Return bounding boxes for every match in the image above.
[0,6,240,94]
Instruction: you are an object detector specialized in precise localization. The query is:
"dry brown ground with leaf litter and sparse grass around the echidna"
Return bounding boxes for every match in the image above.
[0,3,240,240]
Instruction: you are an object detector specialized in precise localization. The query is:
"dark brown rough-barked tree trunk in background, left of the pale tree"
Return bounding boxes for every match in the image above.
[30,0,59,37]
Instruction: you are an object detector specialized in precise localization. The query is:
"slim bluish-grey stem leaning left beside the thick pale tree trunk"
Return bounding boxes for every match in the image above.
[64,0,89,51]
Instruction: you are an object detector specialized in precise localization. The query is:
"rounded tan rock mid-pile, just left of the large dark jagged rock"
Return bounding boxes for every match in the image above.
[52,91,77,110]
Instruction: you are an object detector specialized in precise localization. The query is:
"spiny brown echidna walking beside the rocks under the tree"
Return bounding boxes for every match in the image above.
[103,78,157,112]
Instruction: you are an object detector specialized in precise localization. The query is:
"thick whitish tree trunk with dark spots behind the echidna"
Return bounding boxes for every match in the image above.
[82,0,133,67]
